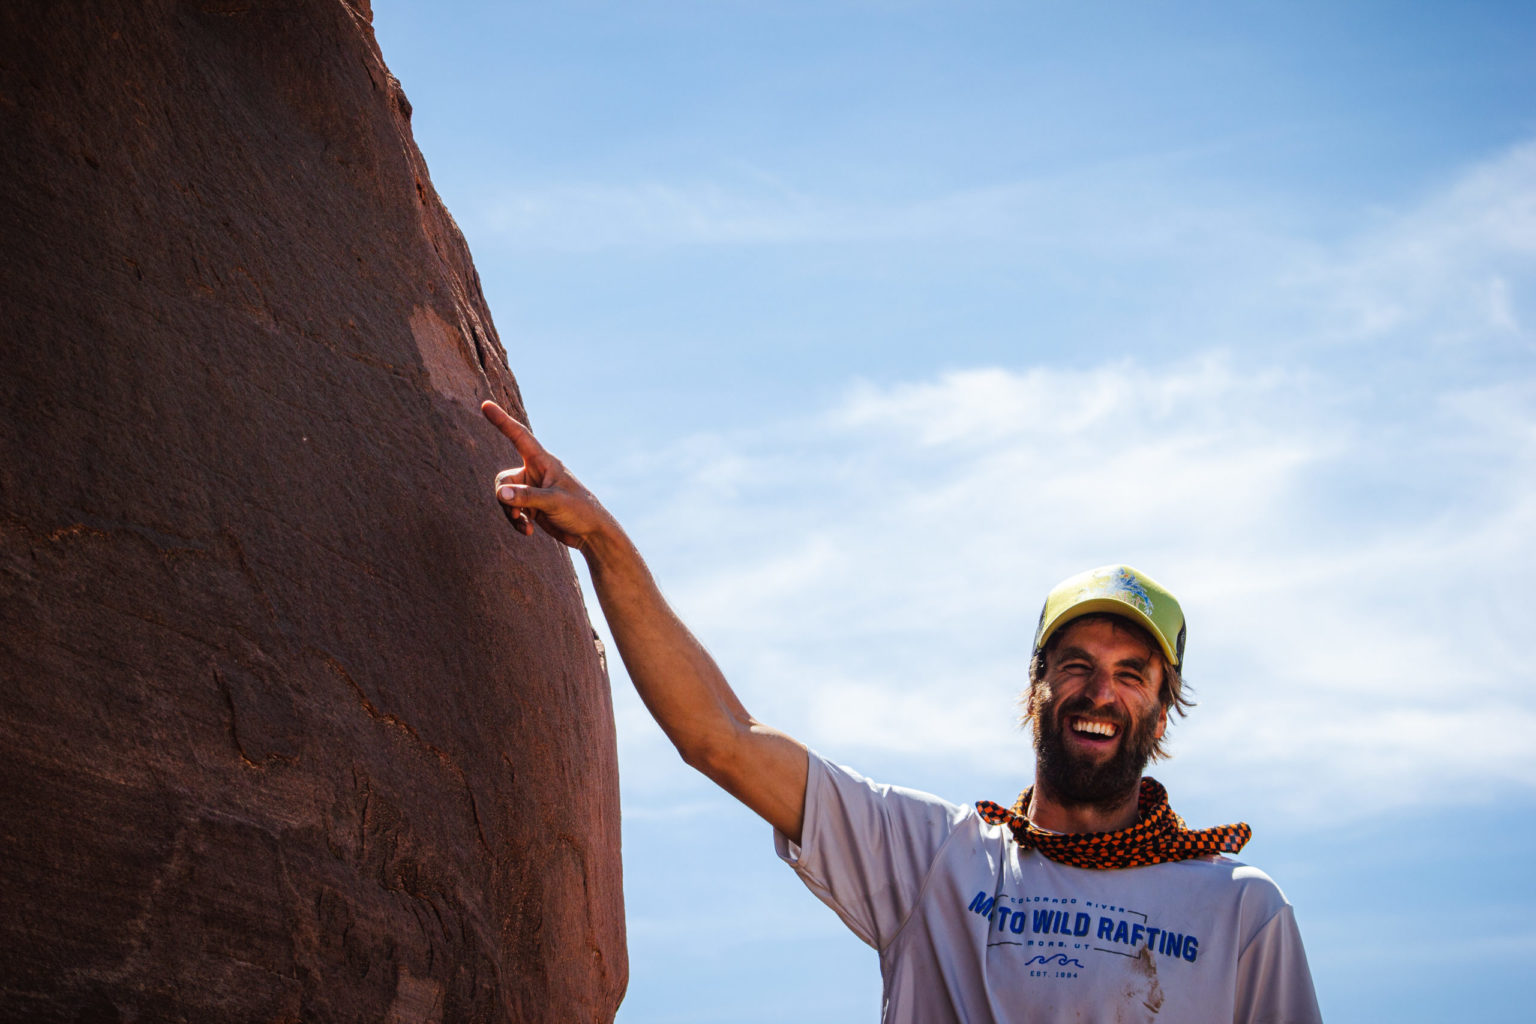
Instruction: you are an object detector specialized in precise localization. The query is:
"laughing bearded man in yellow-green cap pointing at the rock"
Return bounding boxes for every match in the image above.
[484,402,1319,1024]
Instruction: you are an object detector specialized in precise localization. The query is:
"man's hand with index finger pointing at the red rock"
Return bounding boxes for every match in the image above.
[481,402,617,550]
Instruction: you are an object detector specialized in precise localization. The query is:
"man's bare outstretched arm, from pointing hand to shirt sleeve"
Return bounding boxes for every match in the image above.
[481,402,806,843]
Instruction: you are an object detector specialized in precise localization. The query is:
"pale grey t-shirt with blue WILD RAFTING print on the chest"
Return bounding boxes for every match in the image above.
[774,754,1321,1024]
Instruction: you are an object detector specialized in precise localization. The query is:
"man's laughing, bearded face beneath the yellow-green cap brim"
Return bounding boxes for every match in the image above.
[1035,619,1167,809]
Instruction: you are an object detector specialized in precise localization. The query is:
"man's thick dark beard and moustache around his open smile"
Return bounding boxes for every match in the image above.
[1035,694,1158,811]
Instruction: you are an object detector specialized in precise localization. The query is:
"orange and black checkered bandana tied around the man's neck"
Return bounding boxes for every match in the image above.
[975,775,1253,870]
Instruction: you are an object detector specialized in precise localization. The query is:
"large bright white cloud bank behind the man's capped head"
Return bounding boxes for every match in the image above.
[595,356,1536,811]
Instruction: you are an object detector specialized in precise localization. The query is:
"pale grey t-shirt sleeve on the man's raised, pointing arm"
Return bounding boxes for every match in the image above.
[774,754,966,950]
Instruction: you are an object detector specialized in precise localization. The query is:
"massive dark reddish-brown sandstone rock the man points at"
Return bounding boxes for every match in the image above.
[0,0,627,1024]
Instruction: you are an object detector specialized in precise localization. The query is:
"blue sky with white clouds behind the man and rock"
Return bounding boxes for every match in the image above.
[373,0,1536,1024]
